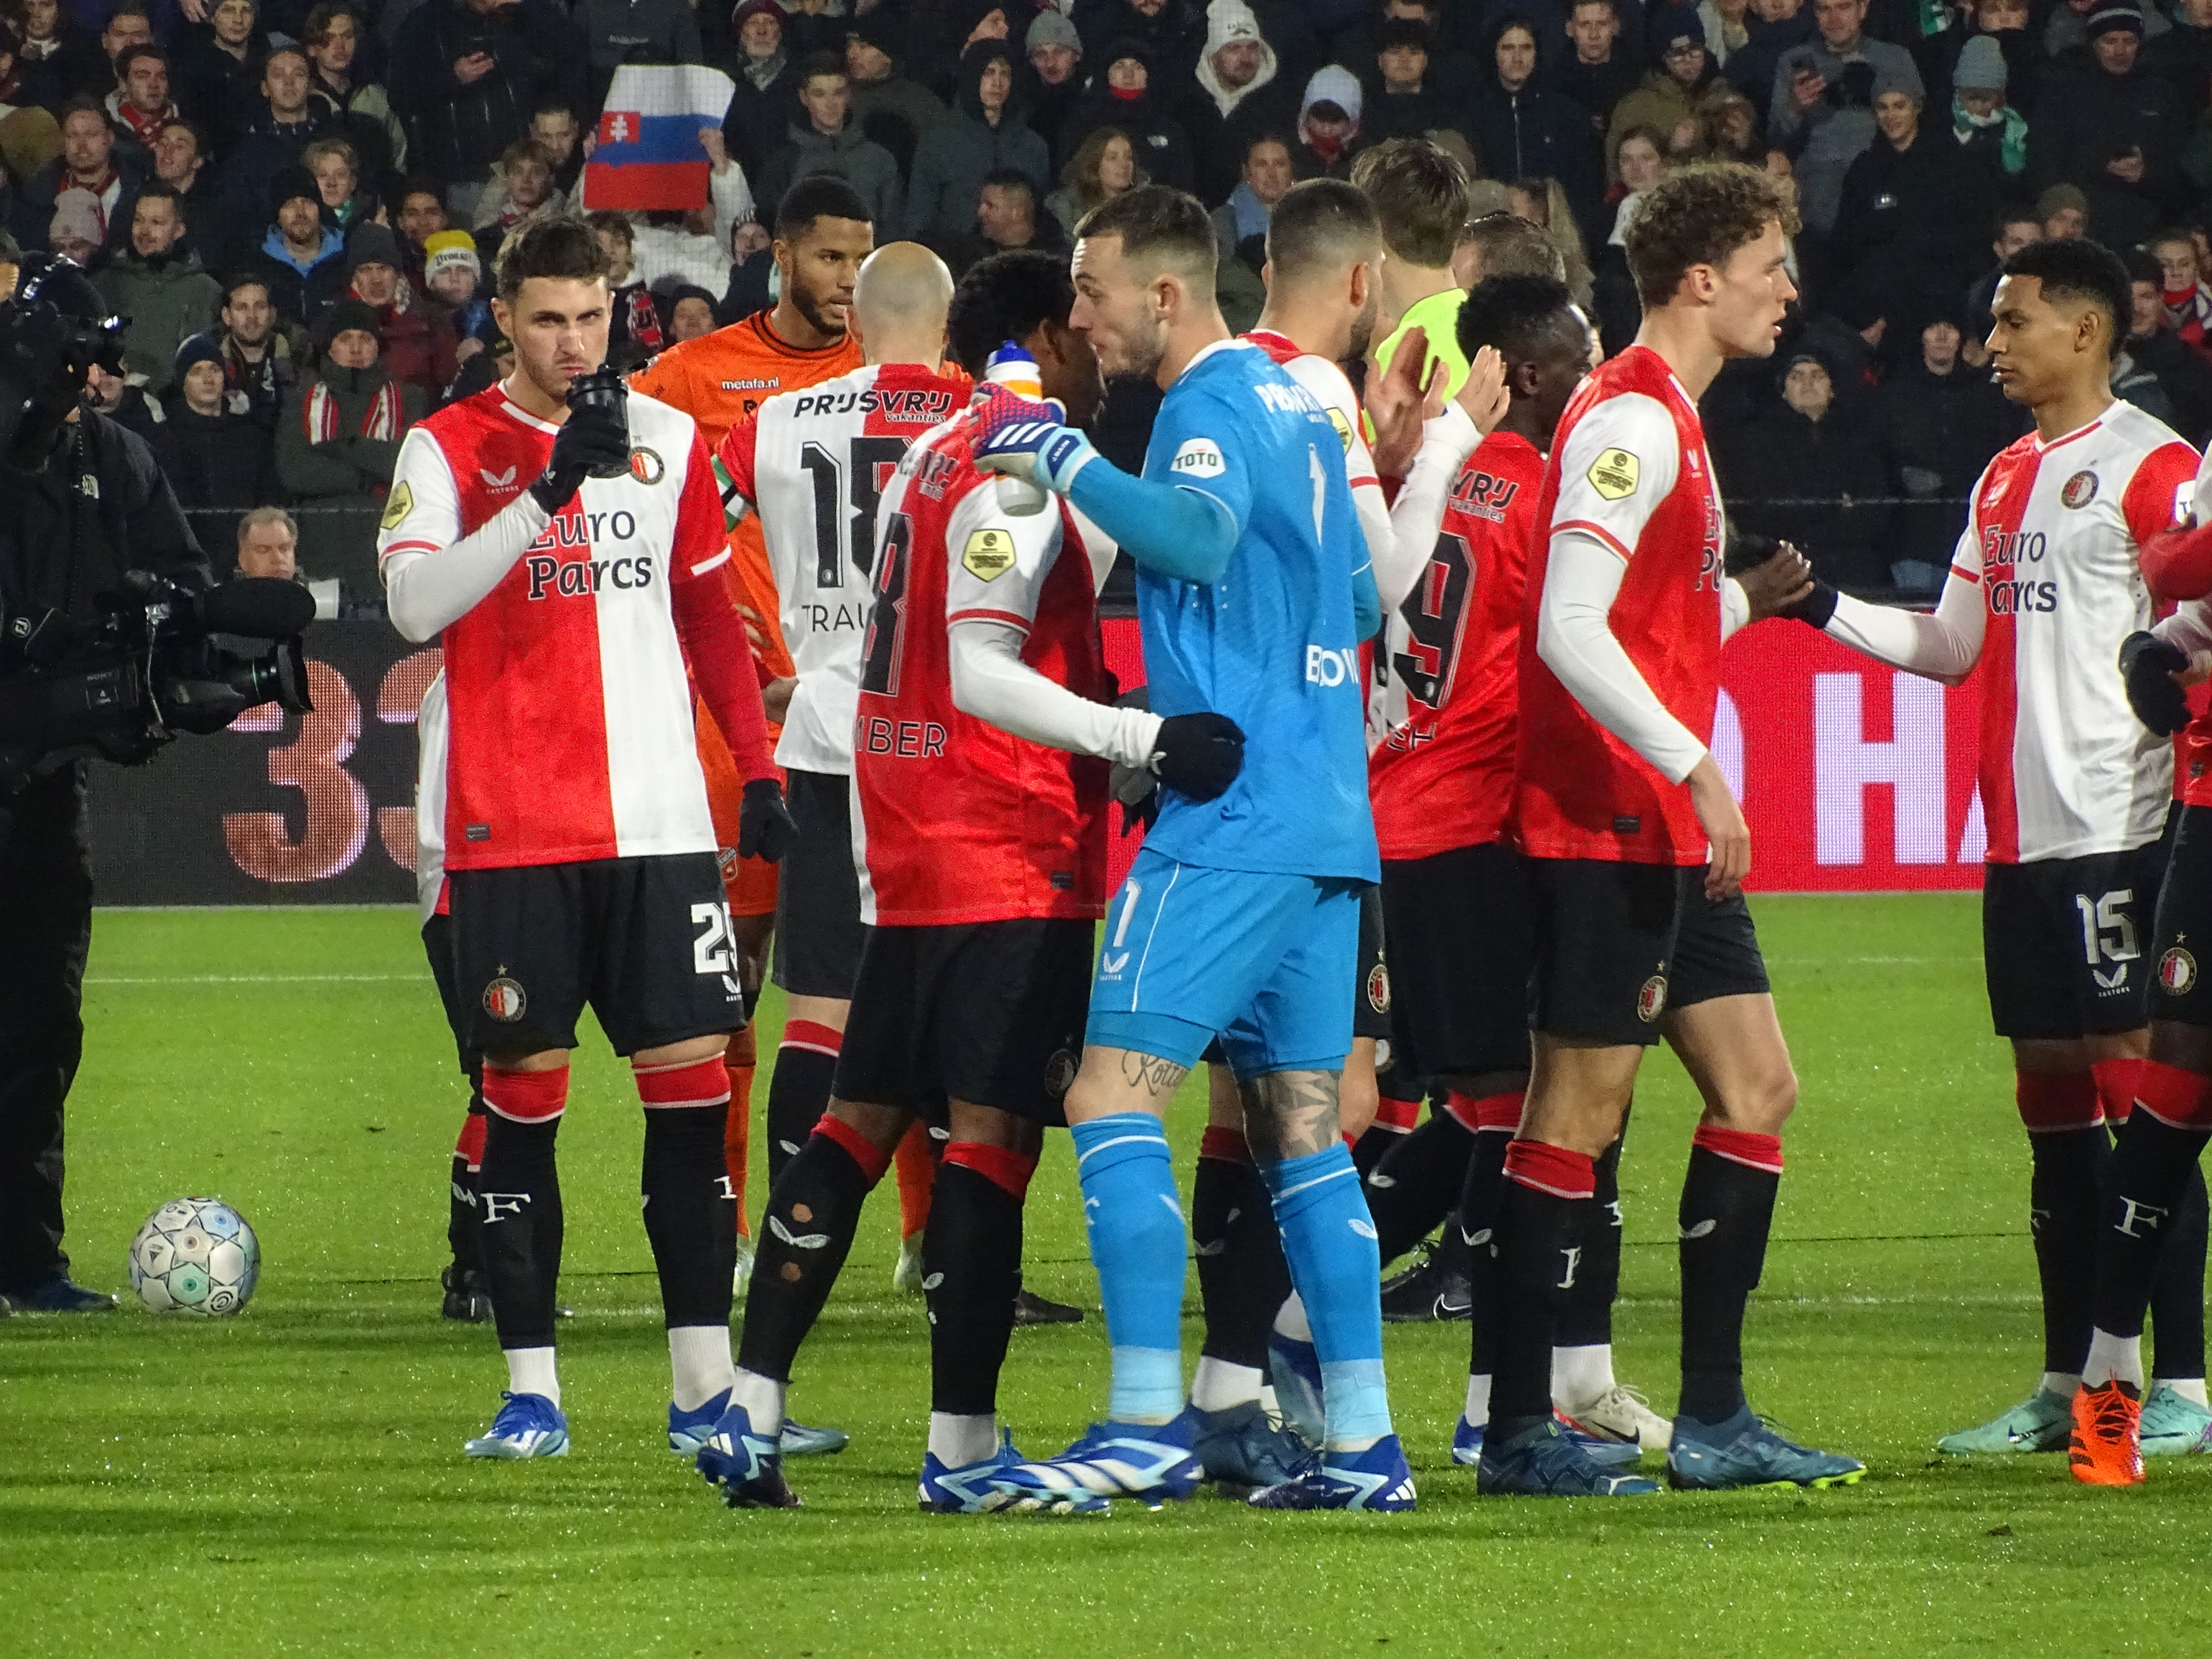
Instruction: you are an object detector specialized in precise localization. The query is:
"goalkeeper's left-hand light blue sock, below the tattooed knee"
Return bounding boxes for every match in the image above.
[1071,1113,1194,1422]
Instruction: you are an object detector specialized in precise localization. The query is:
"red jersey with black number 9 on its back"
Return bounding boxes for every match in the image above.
[1367,431,1544,858]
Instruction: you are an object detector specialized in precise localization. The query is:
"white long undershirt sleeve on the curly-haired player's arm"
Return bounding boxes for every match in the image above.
[1535,531,1706,783]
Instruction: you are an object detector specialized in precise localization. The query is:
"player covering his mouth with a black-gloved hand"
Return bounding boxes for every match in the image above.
[378,219,790,1458]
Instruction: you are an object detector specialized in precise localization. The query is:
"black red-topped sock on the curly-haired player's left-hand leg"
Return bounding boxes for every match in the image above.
[1478,1137,1595,1435]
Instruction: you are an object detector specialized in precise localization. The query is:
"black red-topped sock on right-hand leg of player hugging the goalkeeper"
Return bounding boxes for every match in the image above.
[922,1141,1037,1418]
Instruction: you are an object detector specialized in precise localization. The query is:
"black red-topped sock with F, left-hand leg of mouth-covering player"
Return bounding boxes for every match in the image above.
[476,1066,569,1349]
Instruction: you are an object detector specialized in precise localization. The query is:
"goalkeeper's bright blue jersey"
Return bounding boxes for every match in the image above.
[1137,340,1380,880]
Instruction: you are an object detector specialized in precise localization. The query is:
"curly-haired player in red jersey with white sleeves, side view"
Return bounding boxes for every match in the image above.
[1480,164,1862,1495]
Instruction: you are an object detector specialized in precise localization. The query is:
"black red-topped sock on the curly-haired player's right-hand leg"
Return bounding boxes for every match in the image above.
[1679,1124,1783,1422]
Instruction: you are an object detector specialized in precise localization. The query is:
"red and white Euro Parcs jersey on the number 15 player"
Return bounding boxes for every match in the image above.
[1951,403,2196,865]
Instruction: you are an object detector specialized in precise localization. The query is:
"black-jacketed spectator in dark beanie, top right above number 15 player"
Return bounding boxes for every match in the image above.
[2028,0,2188,248]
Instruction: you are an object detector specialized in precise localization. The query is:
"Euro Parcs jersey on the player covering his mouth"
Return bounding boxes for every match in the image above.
[376,385,730,869]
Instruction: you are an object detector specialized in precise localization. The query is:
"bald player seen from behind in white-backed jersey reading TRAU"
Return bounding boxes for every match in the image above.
[714,241,969,1212]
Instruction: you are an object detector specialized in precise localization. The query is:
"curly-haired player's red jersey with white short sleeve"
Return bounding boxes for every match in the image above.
[1513,345,1728,865]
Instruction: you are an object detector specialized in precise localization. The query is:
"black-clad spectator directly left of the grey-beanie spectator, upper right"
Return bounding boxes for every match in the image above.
[1830,82,1988,338]
